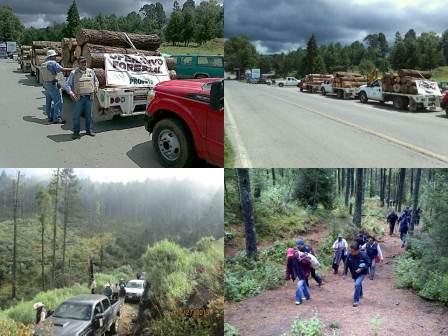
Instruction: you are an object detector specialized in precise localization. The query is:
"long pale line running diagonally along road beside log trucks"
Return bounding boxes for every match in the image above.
[260,93,448,163]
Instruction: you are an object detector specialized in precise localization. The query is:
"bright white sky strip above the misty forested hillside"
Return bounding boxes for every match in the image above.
[0,168,224,187]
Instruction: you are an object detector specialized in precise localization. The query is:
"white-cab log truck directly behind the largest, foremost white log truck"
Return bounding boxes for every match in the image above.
[320,72,367,99]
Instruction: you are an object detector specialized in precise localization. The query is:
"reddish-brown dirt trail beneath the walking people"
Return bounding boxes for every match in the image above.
[225,227,448,336]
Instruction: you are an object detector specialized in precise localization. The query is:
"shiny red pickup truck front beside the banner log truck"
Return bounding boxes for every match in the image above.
[145,78,224,167]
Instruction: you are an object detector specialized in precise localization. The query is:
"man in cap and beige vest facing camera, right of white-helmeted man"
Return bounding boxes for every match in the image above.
[65,57,99,139]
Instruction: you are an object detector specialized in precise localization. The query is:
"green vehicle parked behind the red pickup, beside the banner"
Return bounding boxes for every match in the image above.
[171,55,224,79]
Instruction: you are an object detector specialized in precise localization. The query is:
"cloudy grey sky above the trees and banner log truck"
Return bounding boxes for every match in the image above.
[0,0,219,28]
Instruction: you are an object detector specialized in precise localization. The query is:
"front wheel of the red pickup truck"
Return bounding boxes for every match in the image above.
[152,118,195,168]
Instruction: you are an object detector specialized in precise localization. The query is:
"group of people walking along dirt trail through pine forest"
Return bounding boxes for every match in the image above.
[285,203,422,307]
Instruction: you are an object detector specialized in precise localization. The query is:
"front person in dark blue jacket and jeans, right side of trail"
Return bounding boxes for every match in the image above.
[344,243,371,307]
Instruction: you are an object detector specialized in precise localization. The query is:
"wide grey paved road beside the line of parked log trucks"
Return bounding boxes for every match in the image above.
[225,81,448,168]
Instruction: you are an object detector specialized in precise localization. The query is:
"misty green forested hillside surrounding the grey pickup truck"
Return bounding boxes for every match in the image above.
[0,168,224,335]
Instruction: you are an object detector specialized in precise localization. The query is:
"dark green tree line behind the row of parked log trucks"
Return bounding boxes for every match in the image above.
[224,29,448,78]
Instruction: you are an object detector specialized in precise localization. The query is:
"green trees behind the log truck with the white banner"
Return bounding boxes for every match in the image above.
[0,0,224,46]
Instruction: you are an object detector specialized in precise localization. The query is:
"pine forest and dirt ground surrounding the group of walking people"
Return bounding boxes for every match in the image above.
[224,168,448,336]
